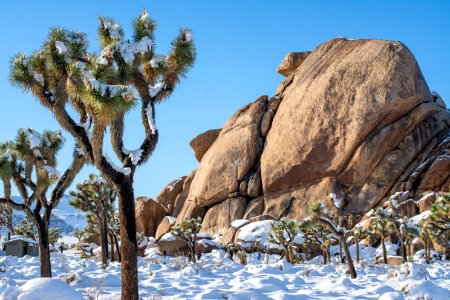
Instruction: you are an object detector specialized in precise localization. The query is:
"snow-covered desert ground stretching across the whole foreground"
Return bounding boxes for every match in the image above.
[0,243,450,300]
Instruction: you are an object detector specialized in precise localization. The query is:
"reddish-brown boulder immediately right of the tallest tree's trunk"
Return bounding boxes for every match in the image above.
[135,197,167,236]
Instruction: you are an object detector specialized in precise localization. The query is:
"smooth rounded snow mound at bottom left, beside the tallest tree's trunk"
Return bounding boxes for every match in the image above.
[17,278,83,300]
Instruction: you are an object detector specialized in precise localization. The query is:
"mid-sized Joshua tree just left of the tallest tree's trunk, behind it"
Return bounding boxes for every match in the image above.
[69,174,116,266]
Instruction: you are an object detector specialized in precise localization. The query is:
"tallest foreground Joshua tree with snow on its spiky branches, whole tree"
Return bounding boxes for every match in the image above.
[10,10,195,299]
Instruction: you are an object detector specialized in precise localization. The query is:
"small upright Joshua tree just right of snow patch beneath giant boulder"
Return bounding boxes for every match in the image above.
[269,218,300,263]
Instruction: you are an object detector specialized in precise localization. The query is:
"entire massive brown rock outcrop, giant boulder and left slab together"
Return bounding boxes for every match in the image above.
[163,39,450,233]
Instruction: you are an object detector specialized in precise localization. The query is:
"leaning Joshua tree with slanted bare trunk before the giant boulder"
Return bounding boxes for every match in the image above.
[310,197,357,278]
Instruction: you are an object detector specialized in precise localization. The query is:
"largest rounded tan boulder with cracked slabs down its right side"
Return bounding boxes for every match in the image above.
[261,39,448,214]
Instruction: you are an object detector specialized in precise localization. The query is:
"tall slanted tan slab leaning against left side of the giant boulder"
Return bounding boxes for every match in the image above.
[188,96,267,206]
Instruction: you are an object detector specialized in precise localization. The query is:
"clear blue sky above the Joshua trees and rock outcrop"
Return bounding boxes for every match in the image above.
[0,0,450,197]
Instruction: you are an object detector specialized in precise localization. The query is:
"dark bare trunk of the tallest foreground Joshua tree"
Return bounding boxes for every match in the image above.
[116,177,139,300]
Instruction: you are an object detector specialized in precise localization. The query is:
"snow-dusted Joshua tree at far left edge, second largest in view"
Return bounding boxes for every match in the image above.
[0,129,85,277]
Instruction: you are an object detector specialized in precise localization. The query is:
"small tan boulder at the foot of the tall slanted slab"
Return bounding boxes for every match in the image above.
[202,198,246,234]
